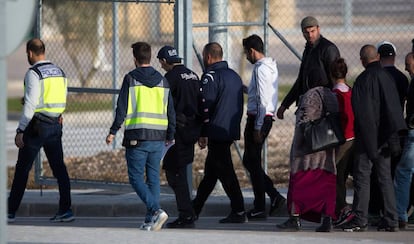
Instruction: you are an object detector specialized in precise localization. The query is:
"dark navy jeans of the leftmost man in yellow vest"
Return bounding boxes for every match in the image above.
[8,118,71,214]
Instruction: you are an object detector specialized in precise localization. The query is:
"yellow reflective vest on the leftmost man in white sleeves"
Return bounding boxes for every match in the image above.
[31,63,67,117]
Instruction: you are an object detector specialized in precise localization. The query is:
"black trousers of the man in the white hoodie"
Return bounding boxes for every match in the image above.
[243,116,280,211]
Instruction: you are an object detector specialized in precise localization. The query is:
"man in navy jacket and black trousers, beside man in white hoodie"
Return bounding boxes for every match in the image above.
[193,42,247,223]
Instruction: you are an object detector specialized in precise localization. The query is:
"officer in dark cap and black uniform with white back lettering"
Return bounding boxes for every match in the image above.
[157,46,201,228]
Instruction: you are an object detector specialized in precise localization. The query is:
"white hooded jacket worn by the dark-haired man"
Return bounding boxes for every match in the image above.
[247,57,279,130]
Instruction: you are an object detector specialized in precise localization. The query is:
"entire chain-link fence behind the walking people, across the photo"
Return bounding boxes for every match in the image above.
[34,0,414,190]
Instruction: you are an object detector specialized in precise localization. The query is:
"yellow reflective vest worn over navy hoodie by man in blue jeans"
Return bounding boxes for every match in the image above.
[125,82,169,130]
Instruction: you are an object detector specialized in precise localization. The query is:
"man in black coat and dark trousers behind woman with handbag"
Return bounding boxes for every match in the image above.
[341,45,407,232]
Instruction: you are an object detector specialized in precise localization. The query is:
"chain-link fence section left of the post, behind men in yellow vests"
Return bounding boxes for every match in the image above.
[37,0,178,187]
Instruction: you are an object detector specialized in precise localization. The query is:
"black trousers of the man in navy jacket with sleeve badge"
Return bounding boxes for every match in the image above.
[193,140,244,214]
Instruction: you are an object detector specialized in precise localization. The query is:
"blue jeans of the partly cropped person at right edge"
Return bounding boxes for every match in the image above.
[394,130,414,222]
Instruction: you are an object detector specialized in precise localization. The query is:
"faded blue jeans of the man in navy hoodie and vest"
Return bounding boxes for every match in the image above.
[125,141,164,222]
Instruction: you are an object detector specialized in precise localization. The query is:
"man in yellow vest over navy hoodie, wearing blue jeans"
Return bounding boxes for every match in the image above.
[106,42,175,231]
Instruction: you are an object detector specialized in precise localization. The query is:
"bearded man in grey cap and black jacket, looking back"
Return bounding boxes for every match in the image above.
[277,16,340,119]
